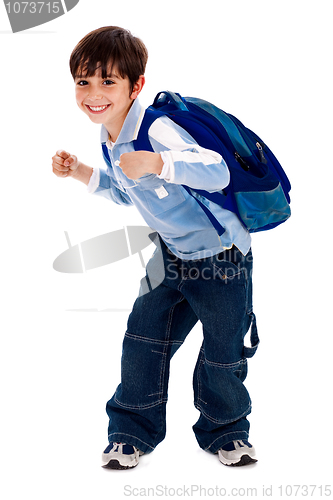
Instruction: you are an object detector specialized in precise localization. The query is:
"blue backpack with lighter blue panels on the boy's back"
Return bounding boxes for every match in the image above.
[134,92,291,235]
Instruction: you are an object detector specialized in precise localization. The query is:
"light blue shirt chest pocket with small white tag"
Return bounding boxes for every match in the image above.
[140,177,186,216]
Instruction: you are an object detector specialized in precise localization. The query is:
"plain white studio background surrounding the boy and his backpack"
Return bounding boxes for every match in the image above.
[0,0,333,500]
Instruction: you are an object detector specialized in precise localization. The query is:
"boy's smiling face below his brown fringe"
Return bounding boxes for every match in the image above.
[74,68,144,142]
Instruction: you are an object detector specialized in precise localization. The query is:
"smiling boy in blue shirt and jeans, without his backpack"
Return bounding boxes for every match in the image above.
[53,26,257,469]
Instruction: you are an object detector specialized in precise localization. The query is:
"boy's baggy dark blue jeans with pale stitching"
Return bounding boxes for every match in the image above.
[106,234,259,453]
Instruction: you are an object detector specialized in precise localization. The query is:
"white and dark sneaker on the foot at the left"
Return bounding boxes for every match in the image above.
[102,443,143,470]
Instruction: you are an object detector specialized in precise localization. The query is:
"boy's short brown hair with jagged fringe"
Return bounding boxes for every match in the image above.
[69,26,148,93]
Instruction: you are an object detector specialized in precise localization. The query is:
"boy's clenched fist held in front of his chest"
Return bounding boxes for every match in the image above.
[119,151,163,180]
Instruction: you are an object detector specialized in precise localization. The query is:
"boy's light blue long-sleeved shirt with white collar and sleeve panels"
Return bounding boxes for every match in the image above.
[88,100,251,260]
